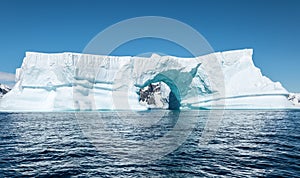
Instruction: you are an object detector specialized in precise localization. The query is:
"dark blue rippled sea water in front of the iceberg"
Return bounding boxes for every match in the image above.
[0,110,300,177]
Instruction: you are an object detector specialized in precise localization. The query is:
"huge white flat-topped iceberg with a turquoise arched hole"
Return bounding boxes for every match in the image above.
[0,49,293,111]
